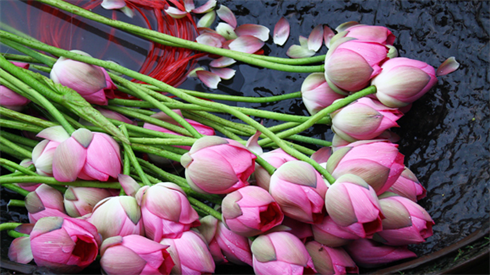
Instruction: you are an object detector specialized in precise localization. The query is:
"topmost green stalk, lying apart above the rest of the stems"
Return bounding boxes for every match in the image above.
[37,0,324,73]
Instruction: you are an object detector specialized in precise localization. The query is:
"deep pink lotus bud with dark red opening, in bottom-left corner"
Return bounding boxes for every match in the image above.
[30,217,101,274]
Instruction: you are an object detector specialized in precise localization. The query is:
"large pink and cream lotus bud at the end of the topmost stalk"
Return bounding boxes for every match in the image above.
[325,38,388,95]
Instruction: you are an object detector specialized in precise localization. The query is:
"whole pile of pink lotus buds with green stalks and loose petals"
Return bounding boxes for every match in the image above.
[0,0,458,274]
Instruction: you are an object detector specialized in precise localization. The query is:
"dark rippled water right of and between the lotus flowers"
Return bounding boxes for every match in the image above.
[0,0,490,274]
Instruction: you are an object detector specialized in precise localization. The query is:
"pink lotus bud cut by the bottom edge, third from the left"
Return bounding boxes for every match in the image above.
[160,230,215,275]
